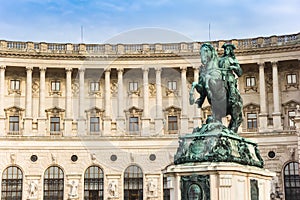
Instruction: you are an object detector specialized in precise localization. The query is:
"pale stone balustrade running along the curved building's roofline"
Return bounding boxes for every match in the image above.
[0,33,300,55]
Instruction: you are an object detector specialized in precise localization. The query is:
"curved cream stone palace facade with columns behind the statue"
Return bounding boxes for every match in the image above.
[0,33,300,200]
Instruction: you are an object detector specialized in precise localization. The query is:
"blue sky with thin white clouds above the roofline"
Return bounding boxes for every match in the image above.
[0,0,300,44]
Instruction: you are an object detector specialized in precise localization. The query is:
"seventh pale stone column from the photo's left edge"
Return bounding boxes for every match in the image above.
[116,68,126,135]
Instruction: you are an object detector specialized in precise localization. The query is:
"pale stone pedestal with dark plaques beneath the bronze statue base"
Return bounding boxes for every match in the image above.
[164,162,275,200]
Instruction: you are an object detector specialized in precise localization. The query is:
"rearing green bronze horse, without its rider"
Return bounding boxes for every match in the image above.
[190,44,243,133]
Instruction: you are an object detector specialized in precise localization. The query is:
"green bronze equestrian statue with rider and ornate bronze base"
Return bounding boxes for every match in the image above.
[174,44,263,167]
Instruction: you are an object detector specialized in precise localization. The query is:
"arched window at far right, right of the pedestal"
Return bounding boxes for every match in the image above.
[284,162,300,200]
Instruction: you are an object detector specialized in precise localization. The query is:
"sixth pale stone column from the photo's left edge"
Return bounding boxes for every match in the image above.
[103,69,111,135]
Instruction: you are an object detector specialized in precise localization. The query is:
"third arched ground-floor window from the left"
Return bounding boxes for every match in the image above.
[84,166,103,200]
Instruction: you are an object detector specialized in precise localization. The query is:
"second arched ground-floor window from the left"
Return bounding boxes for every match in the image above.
[44,166,64,200]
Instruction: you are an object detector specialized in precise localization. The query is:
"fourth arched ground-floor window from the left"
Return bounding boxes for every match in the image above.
[124,165,143,200]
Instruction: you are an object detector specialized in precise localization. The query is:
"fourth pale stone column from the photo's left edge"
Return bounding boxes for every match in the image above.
[64,67,73,136]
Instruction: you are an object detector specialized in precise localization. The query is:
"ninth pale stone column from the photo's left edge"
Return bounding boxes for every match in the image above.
[154,67,164,135]
